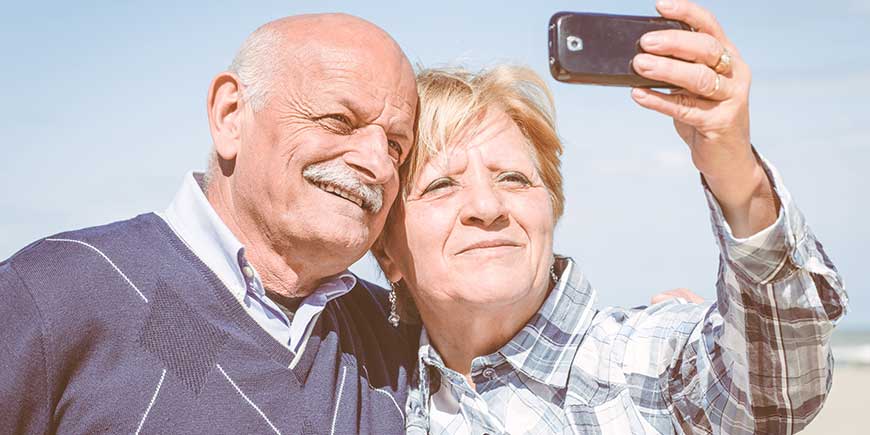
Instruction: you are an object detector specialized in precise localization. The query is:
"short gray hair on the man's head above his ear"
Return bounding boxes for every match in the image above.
[228,27,282,112]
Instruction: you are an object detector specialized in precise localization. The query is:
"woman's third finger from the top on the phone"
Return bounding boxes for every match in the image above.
[632,53,732,101]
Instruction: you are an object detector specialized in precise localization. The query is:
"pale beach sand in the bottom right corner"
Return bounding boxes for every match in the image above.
[801,366,870,435]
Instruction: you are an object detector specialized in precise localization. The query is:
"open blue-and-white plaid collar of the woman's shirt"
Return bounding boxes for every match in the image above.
[418,257,596,388]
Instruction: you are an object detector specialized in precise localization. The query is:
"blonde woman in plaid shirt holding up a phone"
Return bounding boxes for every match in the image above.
[374,2,846,434]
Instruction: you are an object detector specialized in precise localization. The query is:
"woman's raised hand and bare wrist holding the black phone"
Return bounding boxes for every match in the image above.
[632,0,777,237]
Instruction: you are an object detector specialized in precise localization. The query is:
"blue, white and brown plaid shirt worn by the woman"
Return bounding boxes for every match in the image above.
[407,162,847,435]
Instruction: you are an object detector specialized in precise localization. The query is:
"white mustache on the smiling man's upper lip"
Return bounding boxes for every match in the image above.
[302,160,384,214]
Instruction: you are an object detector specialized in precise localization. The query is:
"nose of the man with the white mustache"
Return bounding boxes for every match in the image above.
[344,125,396,184]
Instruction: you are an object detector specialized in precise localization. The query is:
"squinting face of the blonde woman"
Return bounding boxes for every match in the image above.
[381,109,554,311]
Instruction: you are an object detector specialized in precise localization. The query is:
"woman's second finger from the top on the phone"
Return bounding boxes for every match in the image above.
[640,30,725,73]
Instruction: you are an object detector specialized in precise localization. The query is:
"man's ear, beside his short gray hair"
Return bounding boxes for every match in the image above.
[206,72,242,161]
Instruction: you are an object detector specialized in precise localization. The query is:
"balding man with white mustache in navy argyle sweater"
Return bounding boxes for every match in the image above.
[0,15,417,434]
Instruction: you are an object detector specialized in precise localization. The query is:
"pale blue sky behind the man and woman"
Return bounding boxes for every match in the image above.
[0,0,870,328]
